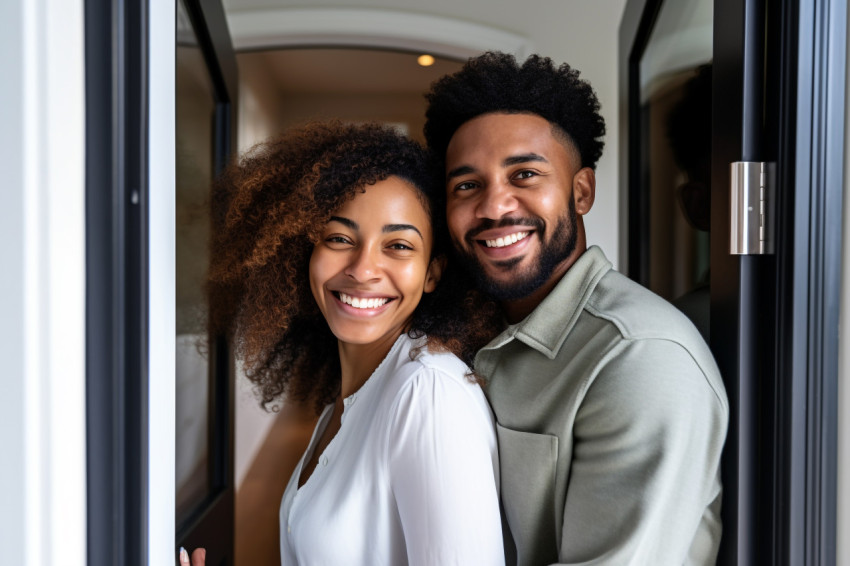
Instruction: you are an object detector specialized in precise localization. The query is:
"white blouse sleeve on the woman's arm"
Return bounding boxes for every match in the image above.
[387,369,504,566]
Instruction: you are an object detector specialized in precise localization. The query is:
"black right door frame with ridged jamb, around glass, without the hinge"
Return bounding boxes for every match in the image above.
[619,0,847,566]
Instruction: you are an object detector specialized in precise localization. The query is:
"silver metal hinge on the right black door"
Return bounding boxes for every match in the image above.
[729,161,776,255]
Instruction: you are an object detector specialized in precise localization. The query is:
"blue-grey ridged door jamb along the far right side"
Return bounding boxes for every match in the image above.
[774,0,847,565]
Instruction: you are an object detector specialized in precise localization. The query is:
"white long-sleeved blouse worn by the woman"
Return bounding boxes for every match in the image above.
[280,334,505,566]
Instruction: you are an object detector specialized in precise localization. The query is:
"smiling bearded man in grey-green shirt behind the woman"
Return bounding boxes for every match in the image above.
[425,53,728,565]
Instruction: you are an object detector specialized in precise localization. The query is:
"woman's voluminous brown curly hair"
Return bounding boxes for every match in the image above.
[207,122,499,410]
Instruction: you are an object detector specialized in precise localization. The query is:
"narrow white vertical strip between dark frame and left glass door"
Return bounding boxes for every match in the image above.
[147,1,176,566]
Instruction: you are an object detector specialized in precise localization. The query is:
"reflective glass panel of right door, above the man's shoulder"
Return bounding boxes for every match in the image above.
[640,0,713,339]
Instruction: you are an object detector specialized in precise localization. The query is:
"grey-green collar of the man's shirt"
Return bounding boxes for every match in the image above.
[485,246,611,359]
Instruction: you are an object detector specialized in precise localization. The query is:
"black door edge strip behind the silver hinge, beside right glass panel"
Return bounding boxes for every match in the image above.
[711,0,773,565]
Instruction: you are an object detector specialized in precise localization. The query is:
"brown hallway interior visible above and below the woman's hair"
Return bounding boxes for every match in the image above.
[225,48,461,566]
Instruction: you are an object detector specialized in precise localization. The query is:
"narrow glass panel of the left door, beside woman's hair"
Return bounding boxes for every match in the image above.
[176,2,215,524]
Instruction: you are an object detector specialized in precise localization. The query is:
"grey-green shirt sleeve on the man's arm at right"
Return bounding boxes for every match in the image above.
[559,340,728,565]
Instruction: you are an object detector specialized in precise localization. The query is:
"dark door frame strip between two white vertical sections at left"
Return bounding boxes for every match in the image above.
[84,0,149,566]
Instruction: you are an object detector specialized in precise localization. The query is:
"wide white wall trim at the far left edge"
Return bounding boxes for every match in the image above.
[0,0,86,566]
